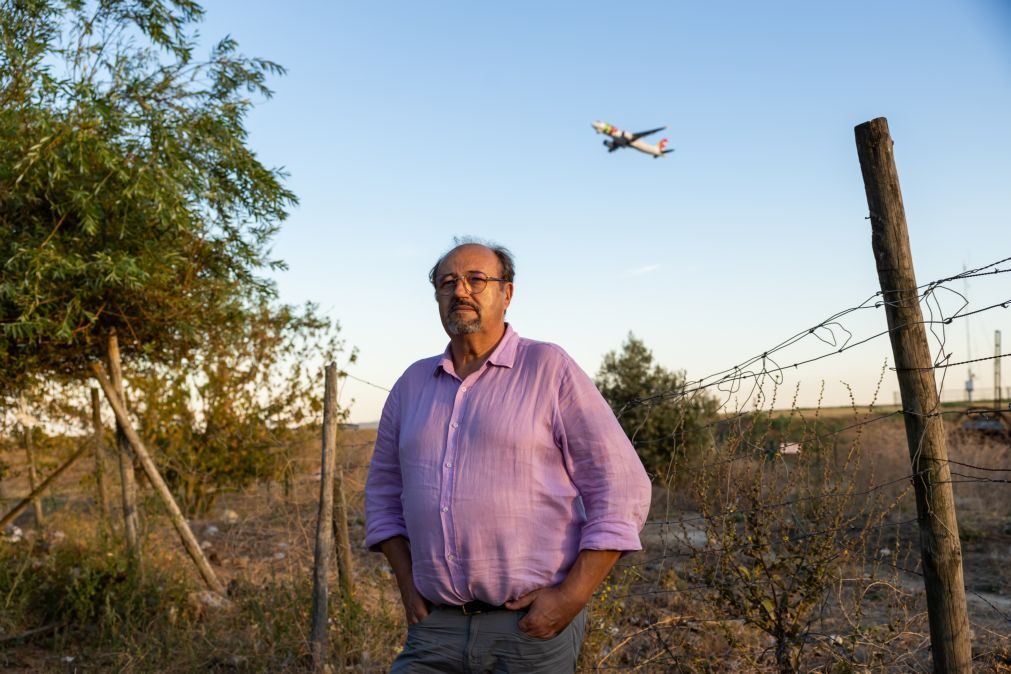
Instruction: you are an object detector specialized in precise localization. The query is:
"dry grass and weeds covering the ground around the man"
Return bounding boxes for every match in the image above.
[0,417,1011,672]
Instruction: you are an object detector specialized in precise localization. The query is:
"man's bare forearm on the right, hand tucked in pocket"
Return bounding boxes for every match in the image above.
[506,550,622,639]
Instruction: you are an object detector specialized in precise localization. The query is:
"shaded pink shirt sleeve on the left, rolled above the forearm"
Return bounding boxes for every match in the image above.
[365,380,407,551]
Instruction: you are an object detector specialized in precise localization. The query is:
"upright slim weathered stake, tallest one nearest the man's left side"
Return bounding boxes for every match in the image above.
[309,363,337,672]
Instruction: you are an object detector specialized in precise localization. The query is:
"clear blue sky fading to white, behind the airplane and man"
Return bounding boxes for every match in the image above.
[201,0,1011,421]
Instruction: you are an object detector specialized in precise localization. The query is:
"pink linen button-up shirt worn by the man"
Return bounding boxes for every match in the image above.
[365,325,650,605]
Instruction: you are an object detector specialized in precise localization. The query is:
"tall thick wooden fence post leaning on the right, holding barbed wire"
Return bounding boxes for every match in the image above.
[854,117,973,673]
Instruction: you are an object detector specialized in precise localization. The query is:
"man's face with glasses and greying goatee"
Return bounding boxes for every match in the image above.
[436,244,513,336]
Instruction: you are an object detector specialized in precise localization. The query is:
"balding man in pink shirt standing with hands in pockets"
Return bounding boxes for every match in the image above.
[365,239,650,674]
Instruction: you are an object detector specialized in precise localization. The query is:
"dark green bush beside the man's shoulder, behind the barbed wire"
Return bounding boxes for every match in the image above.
[596,332,720,480]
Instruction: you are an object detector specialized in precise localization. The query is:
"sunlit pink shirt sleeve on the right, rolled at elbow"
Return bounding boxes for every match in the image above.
[554,361,652,552]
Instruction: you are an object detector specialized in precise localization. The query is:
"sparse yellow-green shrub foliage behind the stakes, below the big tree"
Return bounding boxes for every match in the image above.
[130,303,355,514]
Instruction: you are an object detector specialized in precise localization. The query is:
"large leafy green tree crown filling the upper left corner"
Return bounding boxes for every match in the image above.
[0,0,295,395]
